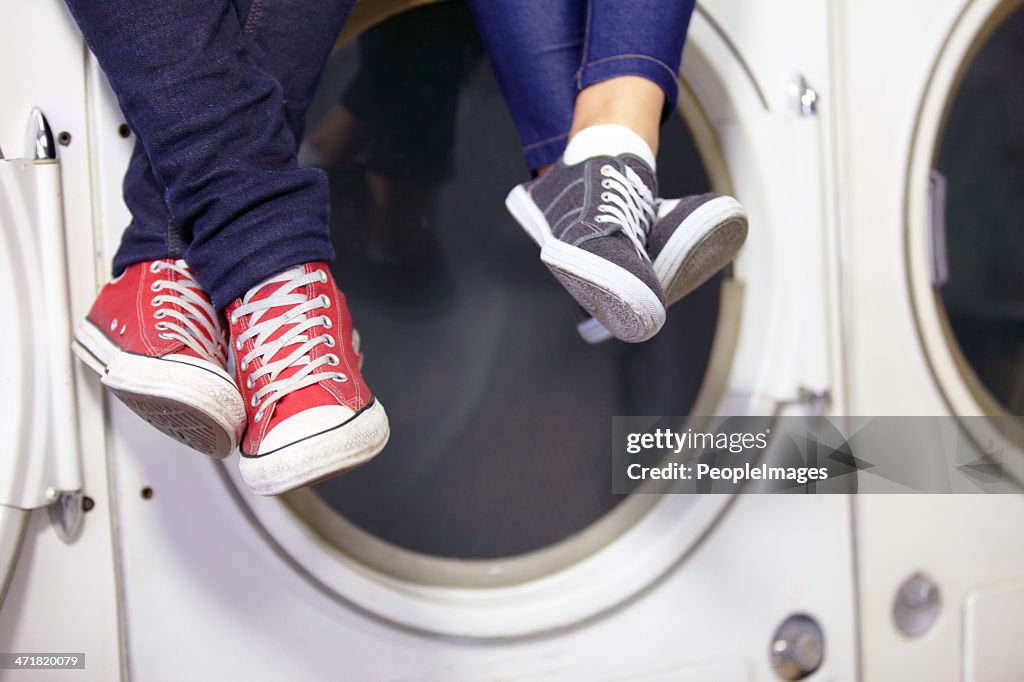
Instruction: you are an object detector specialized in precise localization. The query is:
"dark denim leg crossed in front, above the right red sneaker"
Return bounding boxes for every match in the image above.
[68,0,348,307]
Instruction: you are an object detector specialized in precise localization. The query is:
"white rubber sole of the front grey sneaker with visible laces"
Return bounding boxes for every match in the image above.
[505,185,665,343]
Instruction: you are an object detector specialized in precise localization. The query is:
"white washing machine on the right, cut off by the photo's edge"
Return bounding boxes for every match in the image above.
[835,1,1024,680]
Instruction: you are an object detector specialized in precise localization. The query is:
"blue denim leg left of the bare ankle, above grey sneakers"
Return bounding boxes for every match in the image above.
[470,0,587,169]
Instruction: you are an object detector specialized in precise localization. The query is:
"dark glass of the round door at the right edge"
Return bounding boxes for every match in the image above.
[936,7,1024,415]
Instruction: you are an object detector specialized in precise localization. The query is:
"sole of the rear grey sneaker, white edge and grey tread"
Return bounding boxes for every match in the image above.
[651,197,748,305]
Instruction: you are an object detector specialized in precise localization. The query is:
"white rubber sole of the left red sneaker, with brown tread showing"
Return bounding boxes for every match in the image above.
[72,321,246,459]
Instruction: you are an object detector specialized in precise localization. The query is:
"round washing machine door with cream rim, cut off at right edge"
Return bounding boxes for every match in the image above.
[906,2,1024,482]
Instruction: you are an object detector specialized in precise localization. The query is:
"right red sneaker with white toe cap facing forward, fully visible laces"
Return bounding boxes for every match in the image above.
[225,263,390,495]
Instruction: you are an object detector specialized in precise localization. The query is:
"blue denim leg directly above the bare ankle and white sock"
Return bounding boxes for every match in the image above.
[577,0,694,113]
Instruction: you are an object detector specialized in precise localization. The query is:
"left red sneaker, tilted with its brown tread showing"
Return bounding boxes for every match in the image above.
[72,258,246,458]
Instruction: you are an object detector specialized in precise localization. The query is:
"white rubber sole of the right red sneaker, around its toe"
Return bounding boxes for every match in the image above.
[239,400,391,495]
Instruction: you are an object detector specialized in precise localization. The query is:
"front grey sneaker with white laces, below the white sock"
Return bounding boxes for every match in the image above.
[505,155,665,342]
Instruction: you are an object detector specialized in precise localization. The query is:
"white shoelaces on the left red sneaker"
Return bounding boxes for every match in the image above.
[150,258,227,367]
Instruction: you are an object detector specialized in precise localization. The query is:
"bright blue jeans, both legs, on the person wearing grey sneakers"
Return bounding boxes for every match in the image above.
[470,0,694,169]
